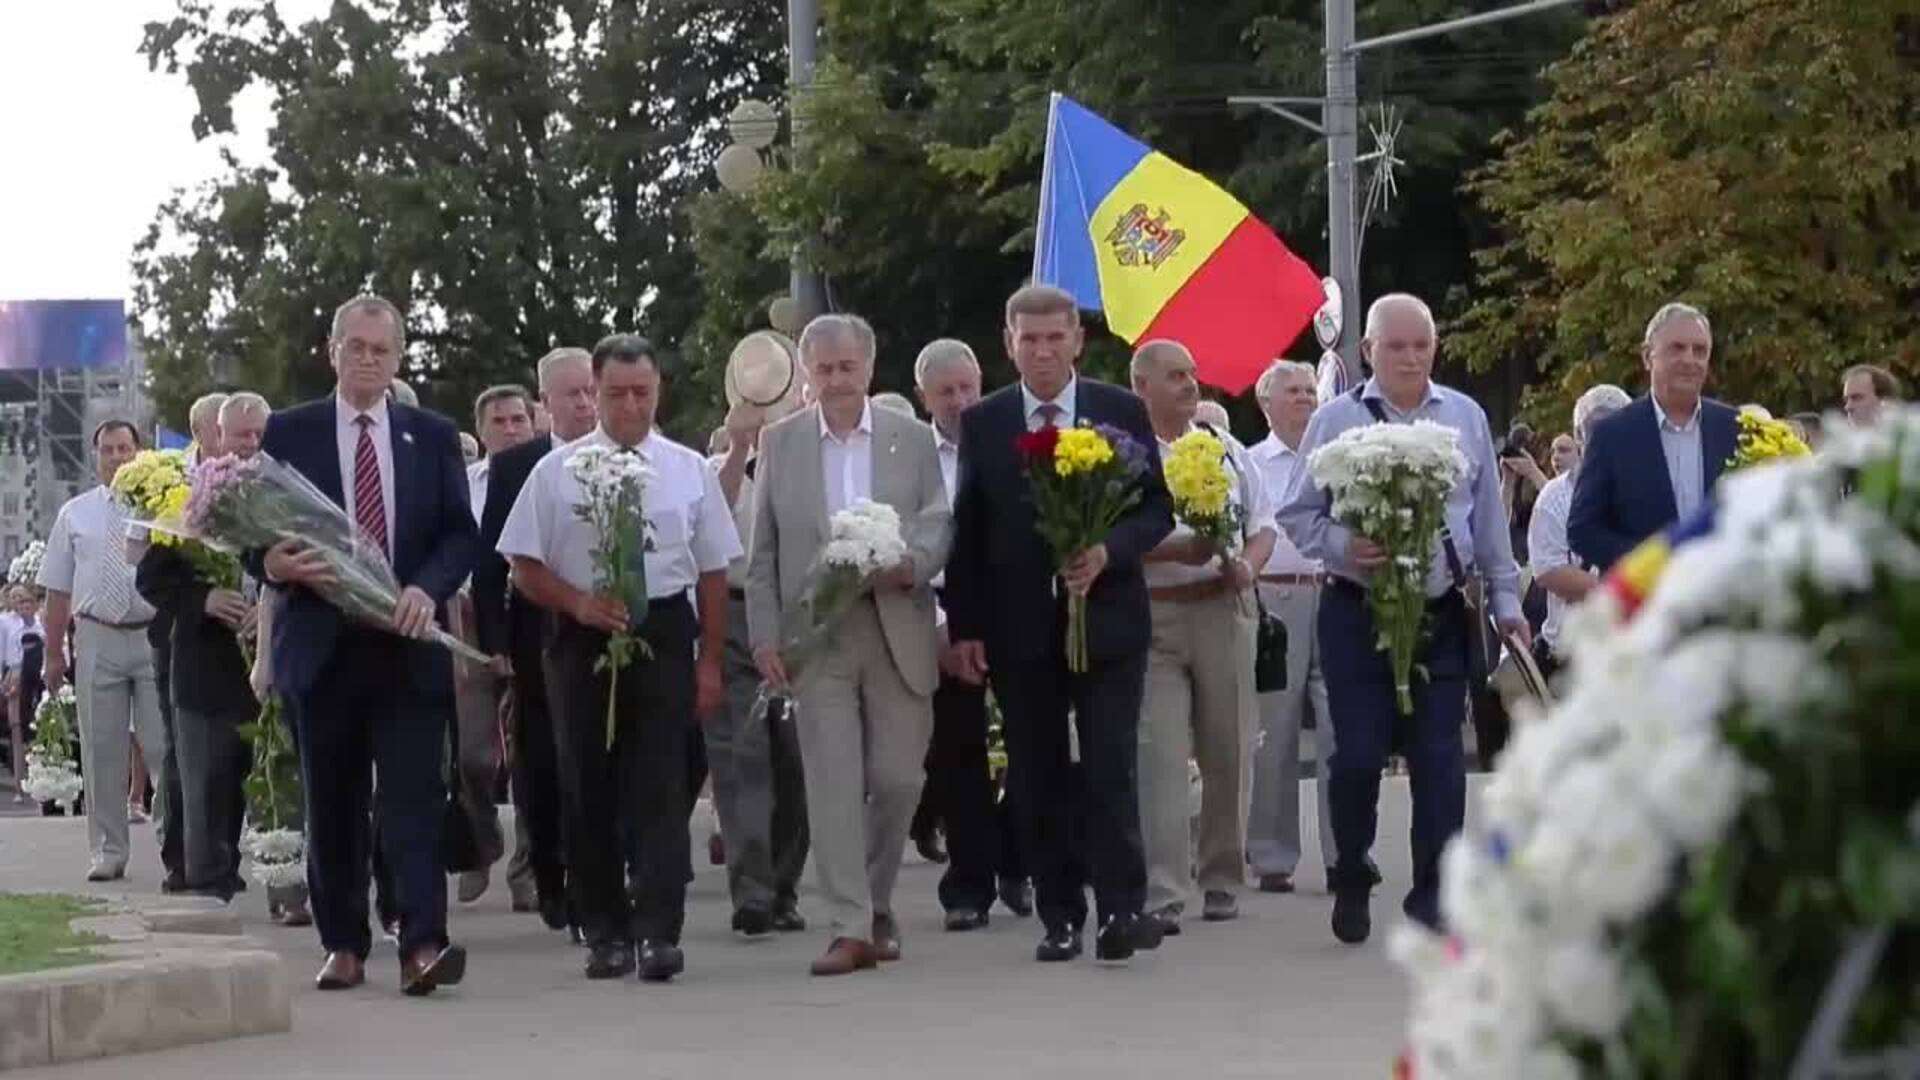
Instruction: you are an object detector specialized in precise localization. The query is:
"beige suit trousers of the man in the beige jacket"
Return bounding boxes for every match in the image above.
[795,600,933,940]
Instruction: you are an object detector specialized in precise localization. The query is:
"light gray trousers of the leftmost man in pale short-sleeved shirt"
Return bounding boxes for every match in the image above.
[72,617,168,869]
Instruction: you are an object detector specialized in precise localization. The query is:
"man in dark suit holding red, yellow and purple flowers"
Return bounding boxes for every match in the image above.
[947,286,1173,961]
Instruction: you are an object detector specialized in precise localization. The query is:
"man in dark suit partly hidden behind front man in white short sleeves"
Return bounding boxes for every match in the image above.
[472,348,597,930]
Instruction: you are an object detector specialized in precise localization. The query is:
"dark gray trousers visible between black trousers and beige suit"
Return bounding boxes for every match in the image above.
[706,596,808,911]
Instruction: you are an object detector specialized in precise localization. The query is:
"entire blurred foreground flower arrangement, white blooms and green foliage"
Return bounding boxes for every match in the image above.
[1392,411,1920,1080]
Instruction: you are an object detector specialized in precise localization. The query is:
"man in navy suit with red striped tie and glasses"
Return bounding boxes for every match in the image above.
[248,296,478,995]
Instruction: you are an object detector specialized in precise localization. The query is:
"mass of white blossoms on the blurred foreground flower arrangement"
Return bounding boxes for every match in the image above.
[1392,413,1920,1080]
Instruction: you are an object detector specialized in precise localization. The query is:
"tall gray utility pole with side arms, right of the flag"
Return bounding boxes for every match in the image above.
[1227,0,1580,384]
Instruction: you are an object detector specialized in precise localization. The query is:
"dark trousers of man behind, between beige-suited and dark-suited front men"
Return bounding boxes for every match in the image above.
[922,678,1016,911]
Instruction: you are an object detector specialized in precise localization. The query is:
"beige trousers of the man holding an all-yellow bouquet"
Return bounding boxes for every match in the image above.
[1140,594,1260,911]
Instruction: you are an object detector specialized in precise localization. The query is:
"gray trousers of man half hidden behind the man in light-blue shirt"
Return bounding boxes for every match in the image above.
[1246,582,1334,876]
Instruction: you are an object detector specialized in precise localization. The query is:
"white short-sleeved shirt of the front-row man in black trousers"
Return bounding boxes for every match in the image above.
[499,429,743,600]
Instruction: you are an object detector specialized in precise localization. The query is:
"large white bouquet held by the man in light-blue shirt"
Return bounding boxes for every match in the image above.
[1308,421,1467,715]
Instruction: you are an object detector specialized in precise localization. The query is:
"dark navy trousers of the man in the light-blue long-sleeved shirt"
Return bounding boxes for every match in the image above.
[1319,584,1467,915]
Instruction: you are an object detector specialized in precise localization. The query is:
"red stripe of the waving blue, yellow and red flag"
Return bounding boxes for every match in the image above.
[1140,217,1323,394]
